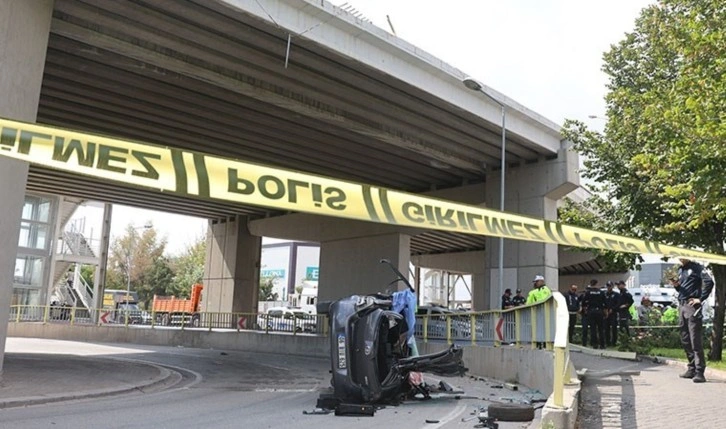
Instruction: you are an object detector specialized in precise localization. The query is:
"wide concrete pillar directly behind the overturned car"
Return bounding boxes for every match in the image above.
[318,233,411,301]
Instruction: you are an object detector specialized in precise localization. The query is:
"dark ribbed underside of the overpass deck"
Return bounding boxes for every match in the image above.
[22,0,556,253]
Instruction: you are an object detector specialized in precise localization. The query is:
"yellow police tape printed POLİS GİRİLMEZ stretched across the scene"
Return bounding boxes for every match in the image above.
[0,119,726,264]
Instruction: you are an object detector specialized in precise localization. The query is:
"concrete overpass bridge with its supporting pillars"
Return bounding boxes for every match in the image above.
[0,0,578,368]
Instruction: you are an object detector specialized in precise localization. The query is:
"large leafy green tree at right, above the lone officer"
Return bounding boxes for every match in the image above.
[565,0,726,360]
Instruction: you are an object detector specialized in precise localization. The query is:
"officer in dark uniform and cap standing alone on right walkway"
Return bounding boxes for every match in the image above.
[671,258,713,383]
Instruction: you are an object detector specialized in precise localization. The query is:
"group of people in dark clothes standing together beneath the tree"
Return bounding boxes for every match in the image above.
[565,279,634,349]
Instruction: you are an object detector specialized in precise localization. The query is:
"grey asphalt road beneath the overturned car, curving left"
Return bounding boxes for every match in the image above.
[0,340,540,429]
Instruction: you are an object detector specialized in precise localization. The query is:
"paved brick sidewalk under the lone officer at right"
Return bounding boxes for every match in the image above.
[570,352,726,429]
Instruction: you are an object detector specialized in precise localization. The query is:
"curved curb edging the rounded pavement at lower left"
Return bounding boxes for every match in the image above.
[0,358,173,409]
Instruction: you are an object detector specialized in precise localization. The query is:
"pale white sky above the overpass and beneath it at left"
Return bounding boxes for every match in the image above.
[78,0,653,255]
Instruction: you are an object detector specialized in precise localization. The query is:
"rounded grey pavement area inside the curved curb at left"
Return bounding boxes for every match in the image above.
[0,339,173,409]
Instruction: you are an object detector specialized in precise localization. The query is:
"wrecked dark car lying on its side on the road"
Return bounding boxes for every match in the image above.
[318,260,466,415]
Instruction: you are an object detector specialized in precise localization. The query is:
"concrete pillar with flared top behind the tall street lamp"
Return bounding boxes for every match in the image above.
[486,148,579,308]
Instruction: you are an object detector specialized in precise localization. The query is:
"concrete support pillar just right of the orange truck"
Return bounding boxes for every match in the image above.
[201,216,262,313]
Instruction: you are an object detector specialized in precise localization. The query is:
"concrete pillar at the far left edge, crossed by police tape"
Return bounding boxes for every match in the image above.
[0,0,53,377]
